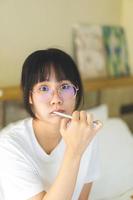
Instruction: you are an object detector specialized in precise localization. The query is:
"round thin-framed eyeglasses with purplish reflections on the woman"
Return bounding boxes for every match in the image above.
[32,83,79,101]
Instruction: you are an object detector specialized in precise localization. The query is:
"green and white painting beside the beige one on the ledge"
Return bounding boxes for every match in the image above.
[102,26,130,77]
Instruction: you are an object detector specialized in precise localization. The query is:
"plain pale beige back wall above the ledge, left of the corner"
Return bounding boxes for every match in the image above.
[0,0,121,86]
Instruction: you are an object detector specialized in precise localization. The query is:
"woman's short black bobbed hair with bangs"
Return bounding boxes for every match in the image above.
[21,48,83,118]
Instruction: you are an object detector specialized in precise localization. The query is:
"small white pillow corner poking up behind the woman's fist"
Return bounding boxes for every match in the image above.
[87,104,108,122]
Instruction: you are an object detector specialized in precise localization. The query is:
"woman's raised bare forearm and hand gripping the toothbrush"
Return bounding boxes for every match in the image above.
[30,111,101,200]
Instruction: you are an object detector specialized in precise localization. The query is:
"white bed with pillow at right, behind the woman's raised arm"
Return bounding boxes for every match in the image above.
[88,105,133,200]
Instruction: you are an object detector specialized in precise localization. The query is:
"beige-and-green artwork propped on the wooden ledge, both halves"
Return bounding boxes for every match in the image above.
[73,25,130,79]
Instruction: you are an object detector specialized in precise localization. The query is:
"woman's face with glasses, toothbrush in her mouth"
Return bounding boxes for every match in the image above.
[29,70,76,123]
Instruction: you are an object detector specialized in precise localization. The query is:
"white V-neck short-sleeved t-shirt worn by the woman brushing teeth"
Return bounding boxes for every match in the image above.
[0,118,99,200]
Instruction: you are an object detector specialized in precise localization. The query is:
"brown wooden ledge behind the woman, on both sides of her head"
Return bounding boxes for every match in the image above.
[0,76,133,101]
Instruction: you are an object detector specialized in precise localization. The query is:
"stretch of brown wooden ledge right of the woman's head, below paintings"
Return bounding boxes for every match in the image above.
[83,76,133,91]
